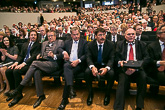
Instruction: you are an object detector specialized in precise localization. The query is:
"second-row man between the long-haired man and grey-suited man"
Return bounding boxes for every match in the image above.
[38,26,48,43]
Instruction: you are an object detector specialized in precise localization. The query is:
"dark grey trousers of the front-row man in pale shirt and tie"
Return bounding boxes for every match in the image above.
[62,62,82,99]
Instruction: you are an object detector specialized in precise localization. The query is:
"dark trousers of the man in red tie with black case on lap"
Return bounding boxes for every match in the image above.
[114,70,146,110]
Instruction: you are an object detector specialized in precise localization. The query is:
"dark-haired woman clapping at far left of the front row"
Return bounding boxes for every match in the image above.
[0,36,19,93]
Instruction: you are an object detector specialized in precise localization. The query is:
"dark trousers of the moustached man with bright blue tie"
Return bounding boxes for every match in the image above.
[85,68,114,95]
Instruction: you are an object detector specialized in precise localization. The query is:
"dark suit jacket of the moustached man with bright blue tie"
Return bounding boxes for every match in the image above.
[87,40,115,68]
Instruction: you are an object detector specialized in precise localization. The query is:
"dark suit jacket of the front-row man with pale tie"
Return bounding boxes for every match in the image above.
[60,39,87,67]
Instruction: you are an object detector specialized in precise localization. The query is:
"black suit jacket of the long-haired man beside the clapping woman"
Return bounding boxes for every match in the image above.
[16,42,41,65]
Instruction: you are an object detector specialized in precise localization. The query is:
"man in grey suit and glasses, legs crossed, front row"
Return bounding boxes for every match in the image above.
[5,31,63,108]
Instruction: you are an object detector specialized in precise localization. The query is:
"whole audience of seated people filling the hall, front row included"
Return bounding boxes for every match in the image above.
[0,6,165,110]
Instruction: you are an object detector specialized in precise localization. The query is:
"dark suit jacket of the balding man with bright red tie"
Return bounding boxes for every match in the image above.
[115,40,149,71]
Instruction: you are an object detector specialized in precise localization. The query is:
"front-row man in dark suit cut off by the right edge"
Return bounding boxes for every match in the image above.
[147,25,165,92]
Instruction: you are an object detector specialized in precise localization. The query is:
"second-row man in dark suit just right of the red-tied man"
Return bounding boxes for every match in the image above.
[134,24,149,41]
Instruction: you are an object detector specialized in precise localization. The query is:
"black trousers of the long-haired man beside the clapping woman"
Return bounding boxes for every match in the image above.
[5,65,29,89]
